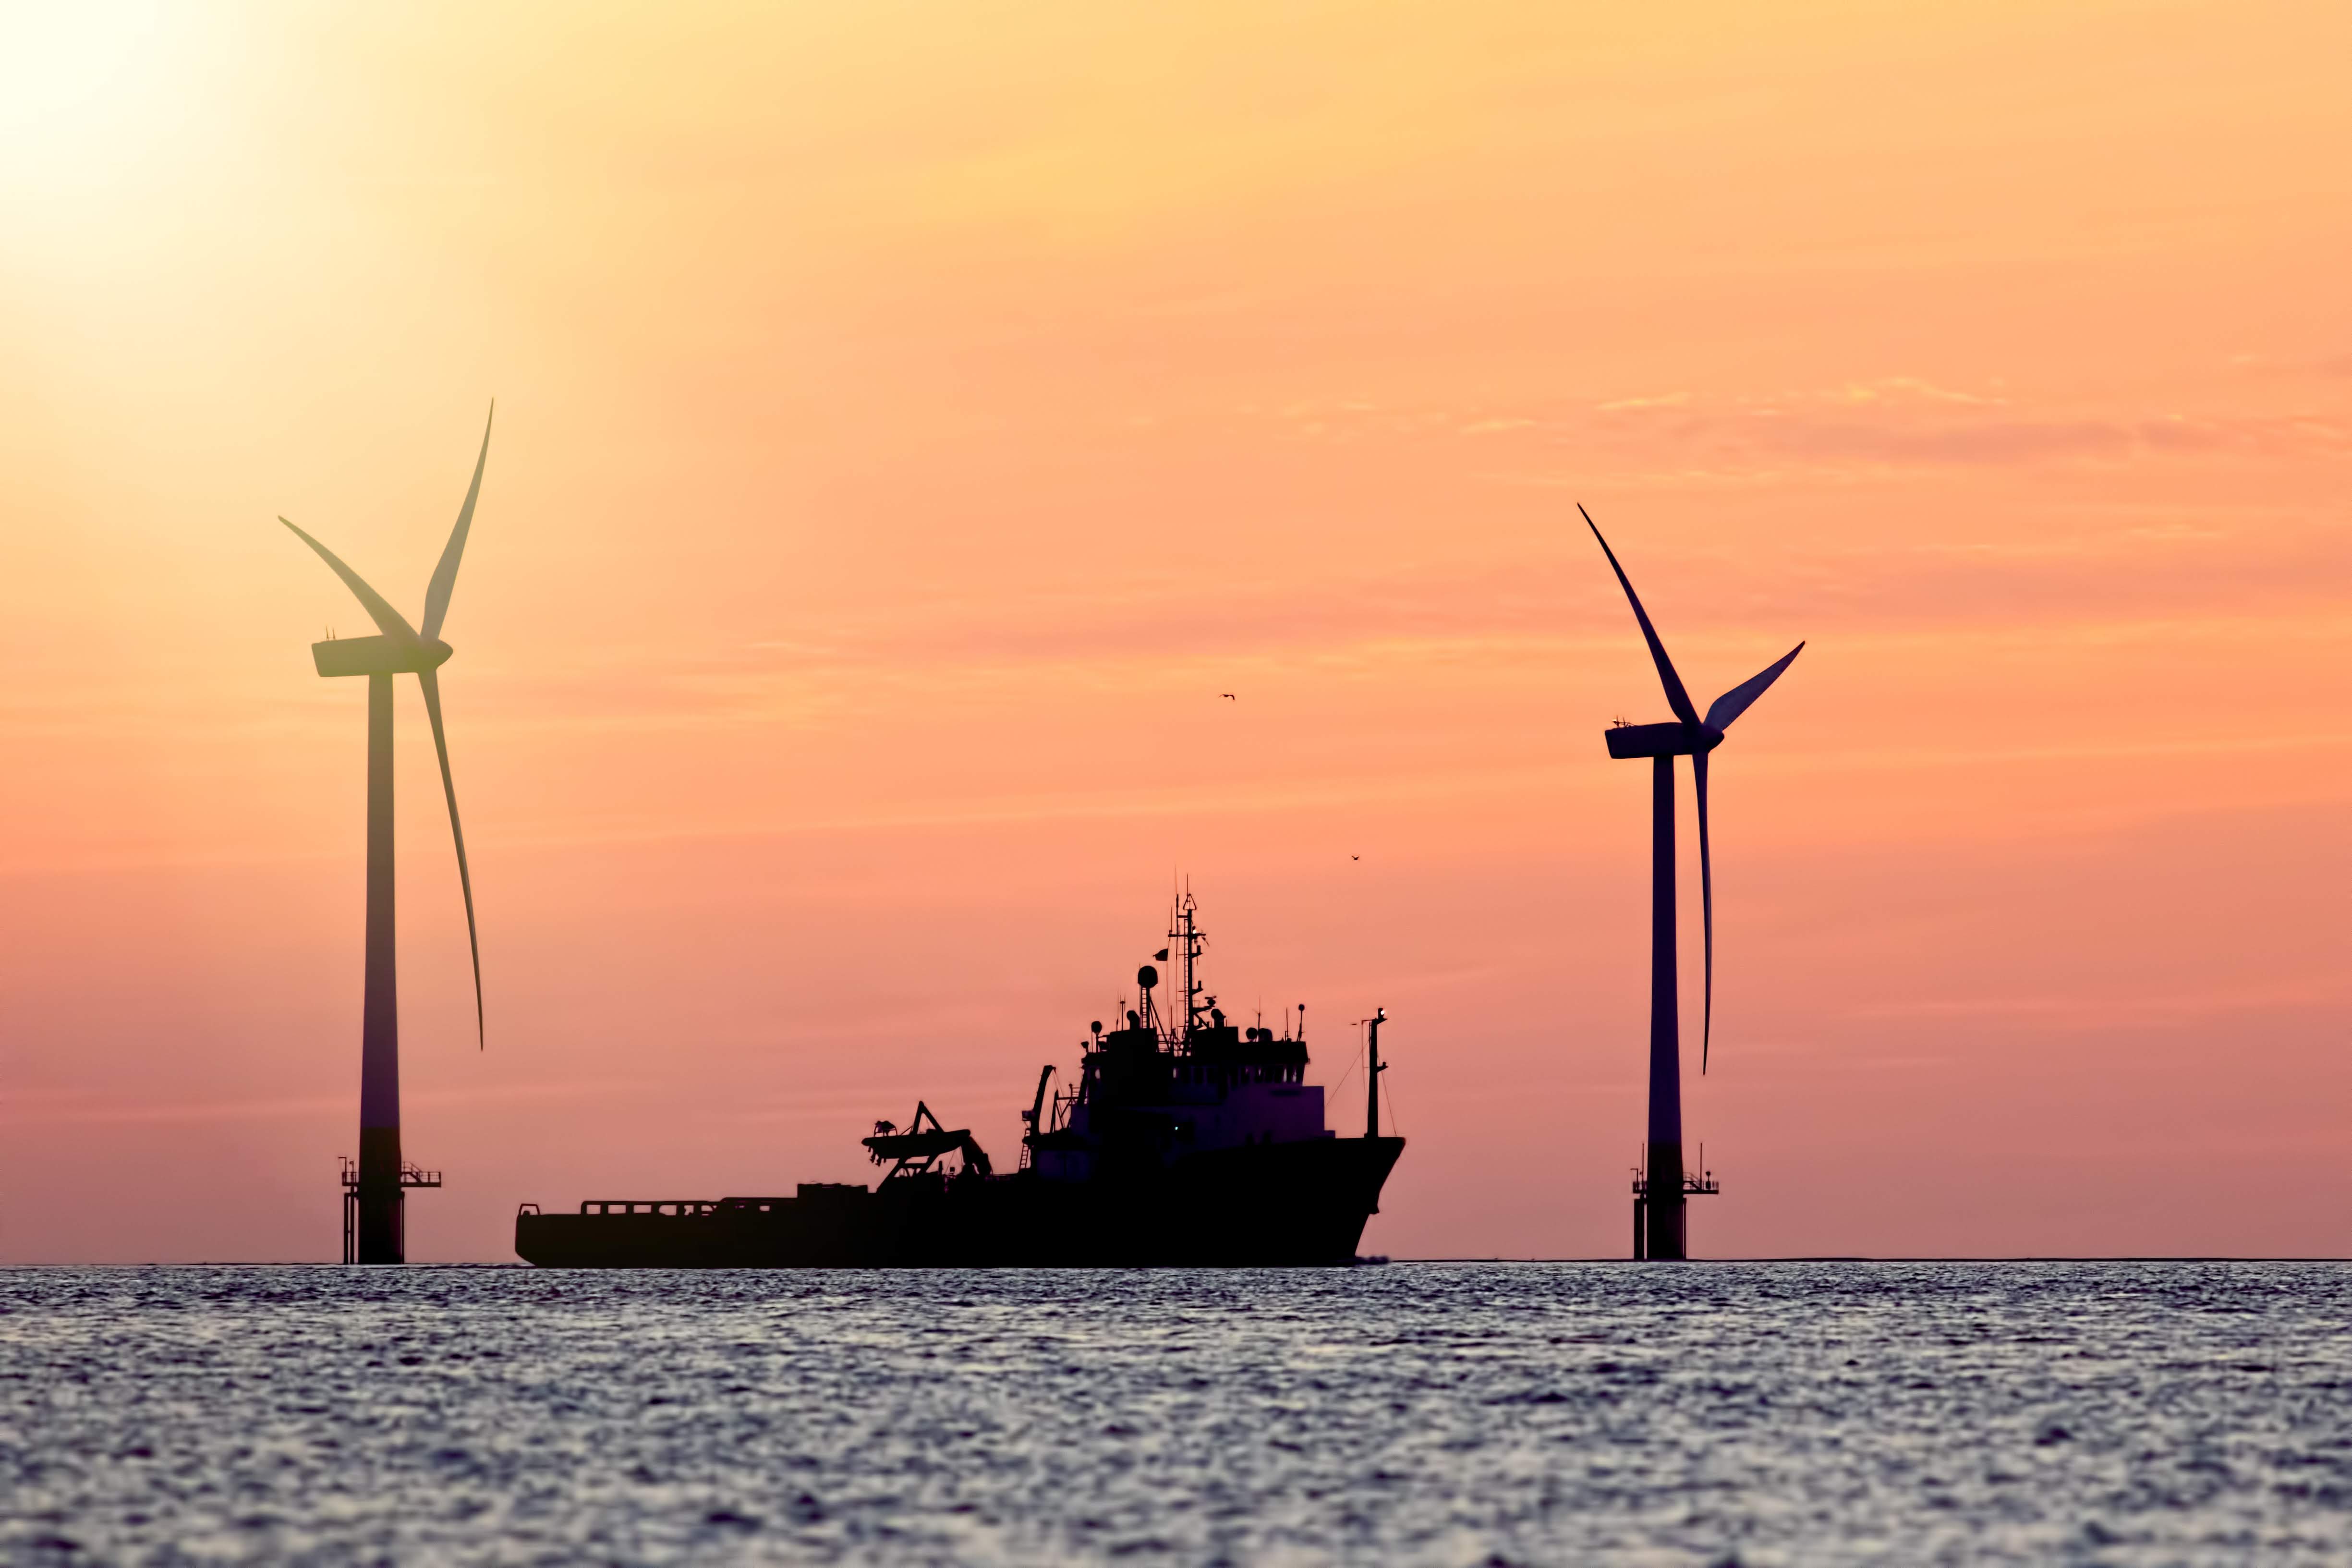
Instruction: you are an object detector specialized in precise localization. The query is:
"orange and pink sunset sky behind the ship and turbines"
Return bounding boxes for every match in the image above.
[0,0,2352,1263]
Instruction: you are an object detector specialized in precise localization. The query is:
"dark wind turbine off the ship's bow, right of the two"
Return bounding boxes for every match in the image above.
[1576,505,1804,1258]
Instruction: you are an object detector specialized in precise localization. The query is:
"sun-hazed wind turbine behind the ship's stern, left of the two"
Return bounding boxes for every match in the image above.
[278,404,498,1263]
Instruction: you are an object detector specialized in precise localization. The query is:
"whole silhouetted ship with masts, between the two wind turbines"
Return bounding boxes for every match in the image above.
[515,896,1404,1269]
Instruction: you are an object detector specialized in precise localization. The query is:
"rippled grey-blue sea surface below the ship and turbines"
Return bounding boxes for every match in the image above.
[0,1263,2352,1563]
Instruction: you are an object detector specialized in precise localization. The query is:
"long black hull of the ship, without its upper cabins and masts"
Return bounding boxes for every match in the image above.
[515,1138,1404,1269]
